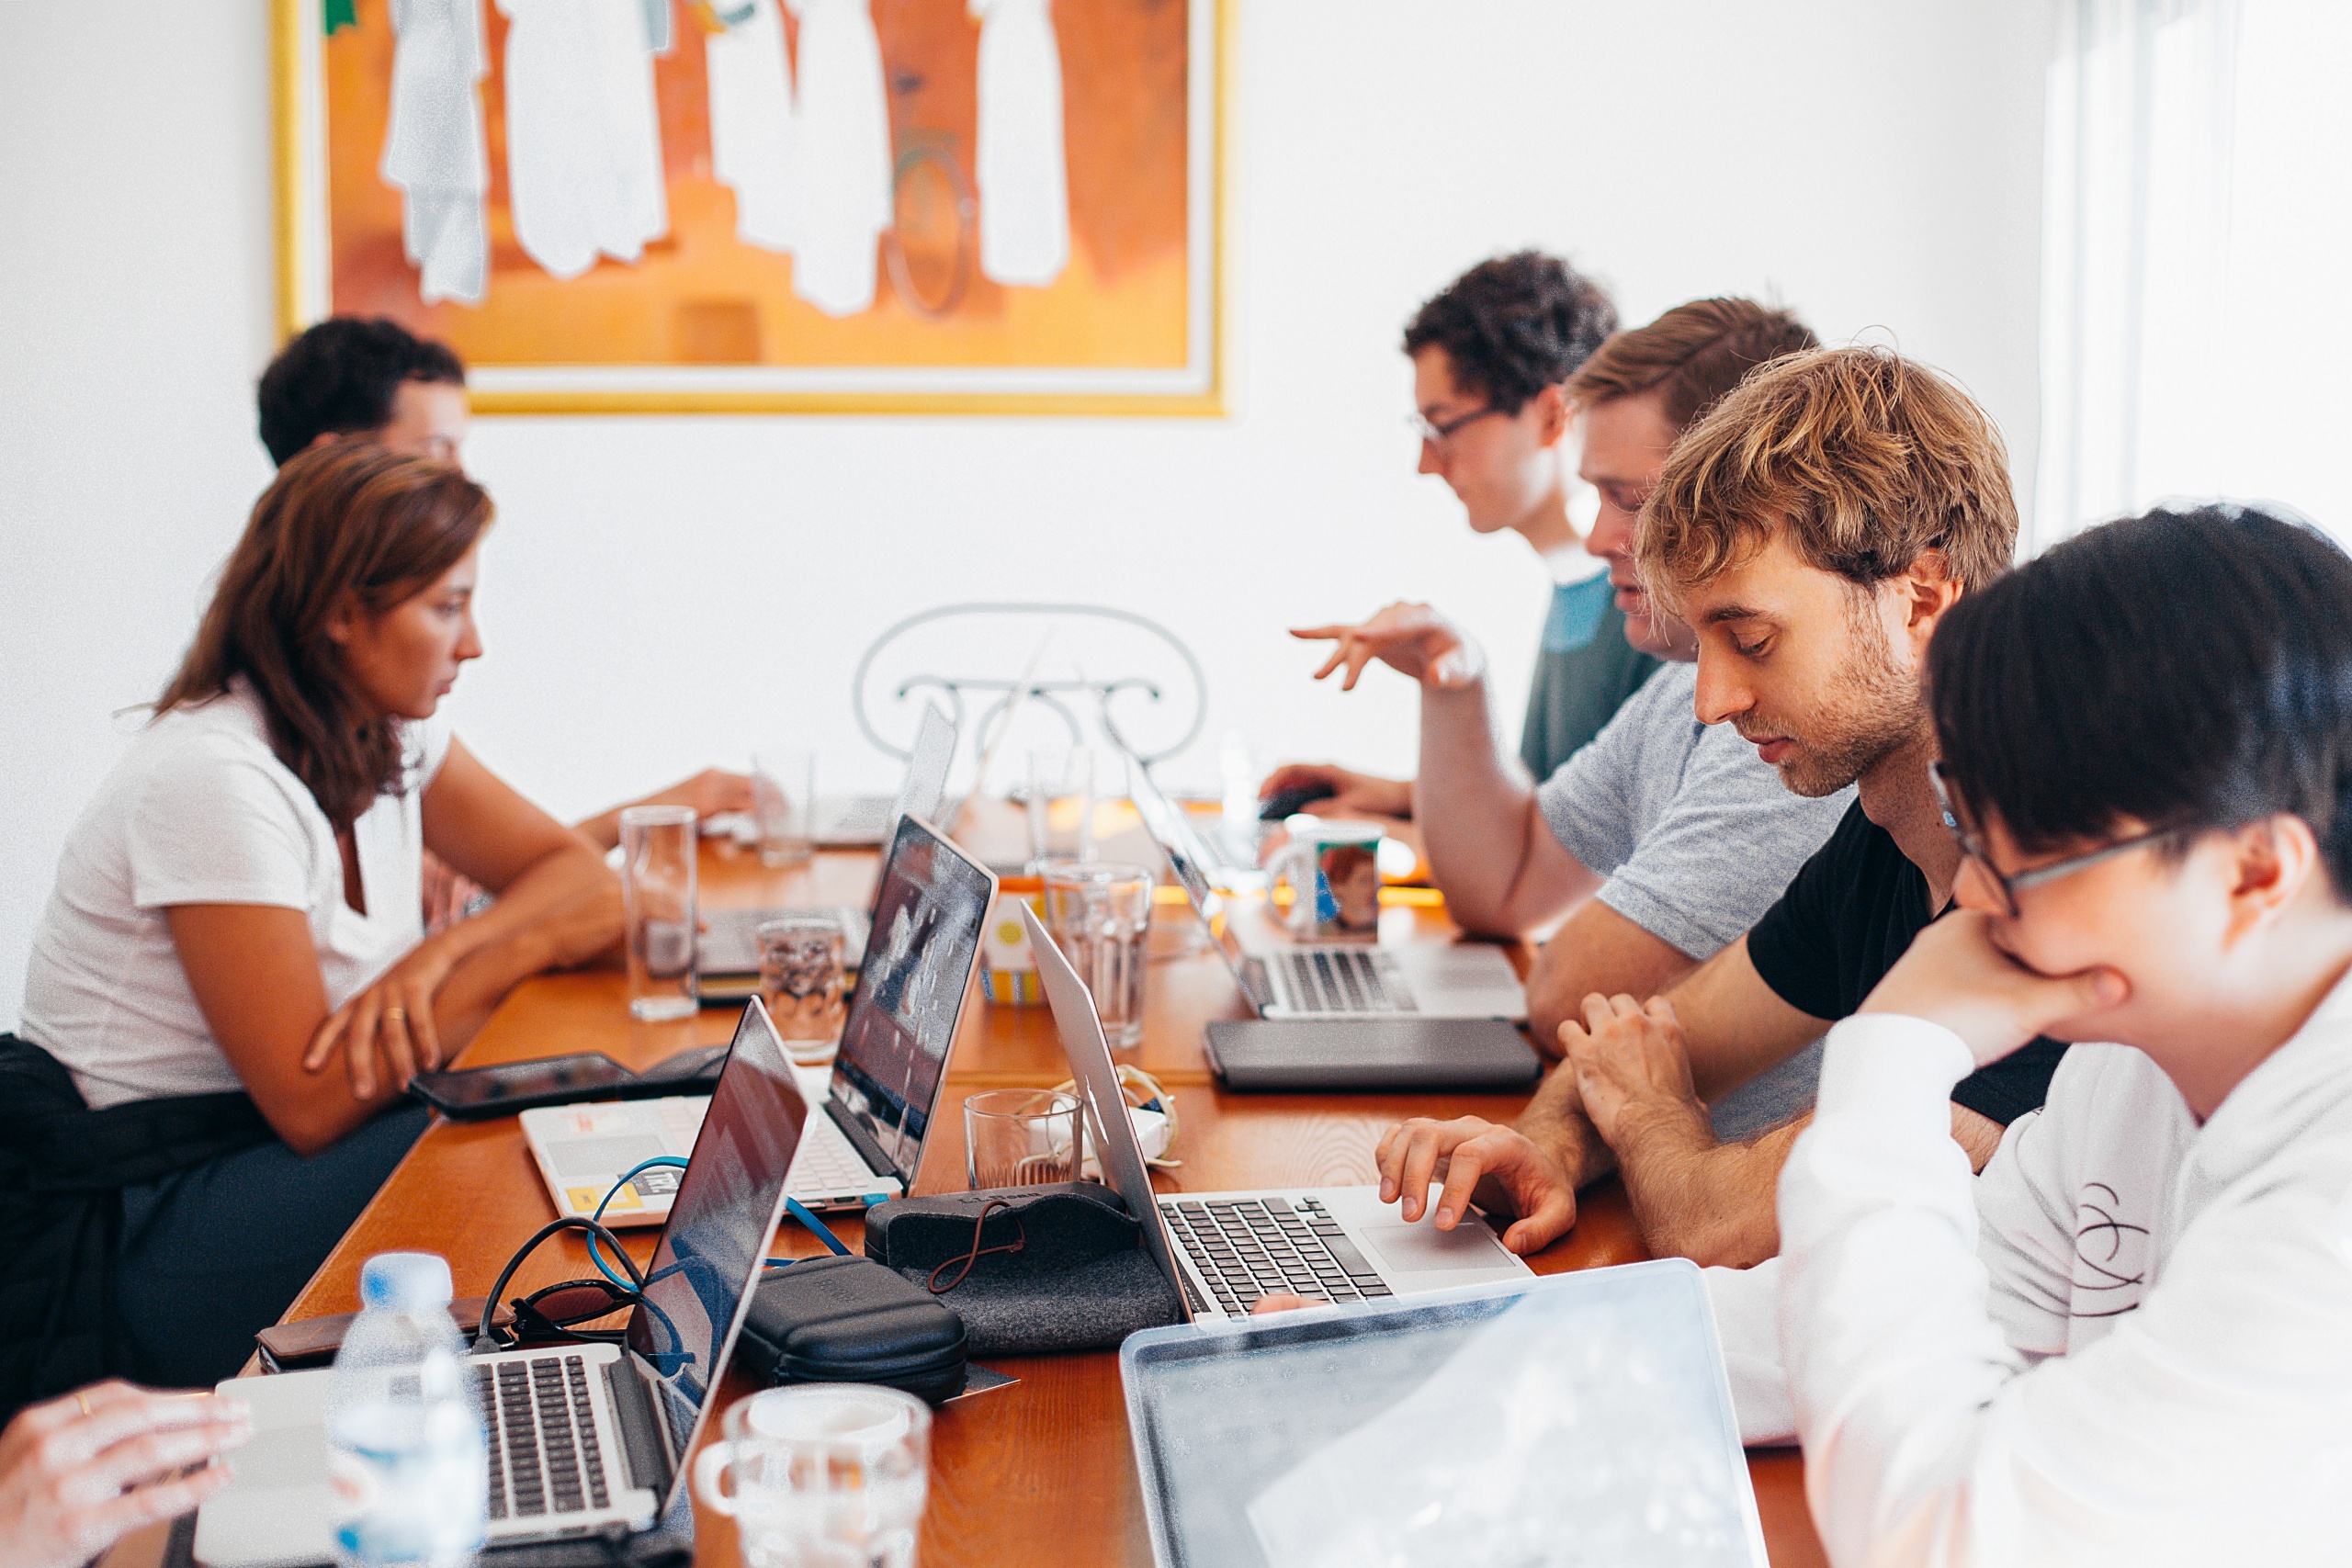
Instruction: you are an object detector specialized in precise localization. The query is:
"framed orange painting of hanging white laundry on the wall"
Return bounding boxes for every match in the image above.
[273,0,1235,413]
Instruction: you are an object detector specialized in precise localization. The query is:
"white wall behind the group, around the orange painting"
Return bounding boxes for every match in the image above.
[0,0,2044,1021]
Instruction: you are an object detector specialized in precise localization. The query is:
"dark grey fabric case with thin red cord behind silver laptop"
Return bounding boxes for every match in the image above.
[865,1182,1183,1357]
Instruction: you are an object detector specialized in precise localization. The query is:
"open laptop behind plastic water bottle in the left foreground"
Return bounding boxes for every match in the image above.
[193,1001,809,1568]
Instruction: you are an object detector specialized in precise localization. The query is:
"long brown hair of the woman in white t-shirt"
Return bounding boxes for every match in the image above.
[155,442,492,832]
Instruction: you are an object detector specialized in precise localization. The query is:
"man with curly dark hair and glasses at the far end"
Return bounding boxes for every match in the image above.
[1261,252,1658,818]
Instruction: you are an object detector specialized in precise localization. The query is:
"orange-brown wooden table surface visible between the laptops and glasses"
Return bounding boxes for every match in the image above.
[253,829,1826,1568]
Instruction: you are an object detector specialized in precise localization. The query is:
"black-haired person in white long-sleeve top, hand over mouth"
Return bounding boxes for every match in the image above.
[1708,508,2352,1565]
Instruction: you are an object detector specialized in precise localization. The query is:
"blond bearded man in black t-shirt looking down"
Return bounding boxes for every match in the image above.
[1381,348,2063,1265]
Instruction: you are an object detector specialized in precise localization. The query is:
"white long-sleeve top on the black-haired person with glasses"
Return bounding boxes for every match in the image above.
[1708,980,2352,1568]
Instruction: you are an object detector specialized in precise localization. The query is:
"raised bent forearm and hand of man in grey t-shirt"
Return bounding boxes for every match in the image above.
[1291,604,1601,936]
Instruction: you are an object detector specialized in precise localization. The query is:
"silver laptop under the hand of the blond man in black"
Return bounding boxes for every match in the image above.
[1018,903,1529,1324]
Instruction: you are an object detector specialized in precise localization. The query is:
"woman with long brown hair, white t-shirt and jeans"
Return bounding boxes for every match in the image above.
[21,442,621,1382]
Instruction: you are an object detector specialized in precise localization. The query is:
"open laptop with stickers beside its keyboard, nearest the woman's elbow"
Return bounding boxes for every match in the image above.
[522,816,997,1224]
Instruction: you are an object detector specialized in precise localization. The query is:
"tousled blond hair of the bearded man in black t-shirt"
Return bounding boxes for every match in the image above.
[1634,348,2018,604]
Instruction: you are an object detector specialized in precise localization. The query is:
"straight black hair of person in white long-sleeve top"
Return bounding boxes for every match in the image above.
[1927,505,2352,896]
